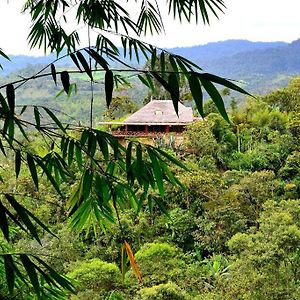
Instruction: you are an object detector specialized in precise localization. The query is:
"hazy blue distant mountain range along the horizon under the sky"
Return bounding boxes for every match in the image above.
[0,40,300,93]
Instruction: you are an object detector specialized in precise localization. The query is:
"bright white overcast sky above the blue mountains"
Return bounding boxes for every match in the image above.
[0,0,300,55]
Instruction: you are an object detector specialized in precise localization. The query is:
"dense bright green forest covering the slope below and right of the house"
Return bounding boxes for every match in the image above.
[0,78,300,300]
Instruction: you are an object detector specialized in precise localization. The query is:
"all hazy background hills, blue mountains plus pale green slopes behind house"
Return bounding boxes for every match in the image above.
[0,40,300,113]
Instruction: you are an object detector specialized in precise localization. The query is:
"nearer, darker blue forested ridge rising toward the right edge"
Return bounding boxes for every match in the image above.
[204,40,300,94]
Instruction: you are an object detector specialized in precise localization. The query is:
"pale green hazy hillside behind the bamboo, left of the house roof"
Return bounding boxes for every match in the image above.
[0,65,146,124]
